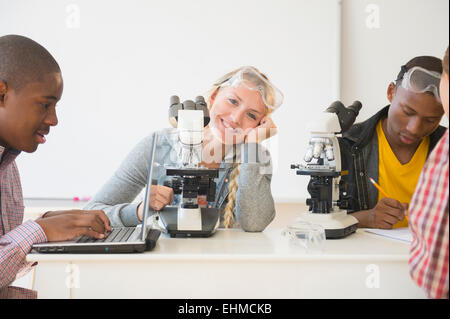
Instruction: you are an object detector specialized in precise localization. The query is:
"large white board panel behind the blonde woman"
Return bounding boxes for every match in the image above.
[0,0,339,201]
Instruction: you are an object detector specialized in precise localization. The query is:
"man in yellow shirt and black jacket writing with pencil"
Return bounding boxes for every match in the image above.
[340,56,445,229]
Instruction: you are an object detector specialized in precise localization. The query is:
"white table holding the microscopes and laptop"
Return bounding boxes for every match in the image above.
[28,228,425,299]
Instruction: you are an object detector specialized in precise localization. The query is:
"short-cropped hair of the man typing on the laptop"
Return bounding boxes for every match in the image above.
[0,34,61,90]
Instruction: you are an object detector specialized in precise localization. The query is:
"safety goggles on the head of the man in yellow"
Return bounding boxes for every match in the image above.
[402,66,441,103]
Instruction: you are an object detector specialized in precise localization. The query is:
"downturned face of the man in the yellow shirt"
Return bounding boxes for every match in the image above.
[386,83,444,147]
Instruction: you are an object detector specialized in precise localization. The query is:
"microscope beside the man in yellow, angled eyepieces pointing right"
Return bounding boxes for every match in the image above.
[291,101,362,239]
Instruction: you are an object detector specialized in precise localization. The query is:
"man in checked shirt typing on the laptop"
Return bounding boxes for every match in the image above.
[0,35,110,299]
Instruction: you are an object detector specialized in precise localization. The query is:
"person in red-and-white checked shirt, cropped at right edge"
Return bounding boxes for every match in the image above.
[409,48,449,299]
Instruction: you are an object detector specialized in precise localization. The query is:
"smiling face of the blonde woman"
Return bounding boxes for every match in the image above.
[210,85,267,144]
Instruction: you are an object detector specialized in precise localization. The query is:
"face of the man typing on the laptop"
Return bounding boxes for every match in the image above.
[0,73,63,153]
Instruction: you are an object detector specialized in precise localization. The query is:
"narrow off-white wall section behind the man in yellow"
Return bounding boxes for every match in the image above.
[341,0,449,125]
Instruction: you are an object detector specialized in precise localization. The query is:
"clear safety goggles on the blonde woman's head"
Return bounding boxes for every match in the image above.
[221,66,284,110]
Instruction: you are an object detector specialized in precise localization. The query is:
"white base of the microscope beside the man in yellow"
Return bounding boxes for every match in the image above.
[299,211,358,239]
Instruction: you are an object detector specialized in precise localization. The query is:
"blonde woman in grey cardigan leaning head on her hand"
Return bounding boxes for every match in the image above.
[85,67,283,232]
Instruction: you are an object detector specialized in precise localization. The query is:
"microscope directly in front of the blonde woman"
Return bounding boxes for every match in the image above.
[159,96,220,237]
